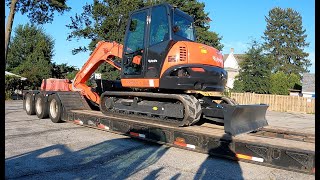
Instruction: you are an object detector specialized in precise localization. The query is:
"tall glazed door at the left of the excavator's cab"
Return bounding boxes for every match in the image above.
[121,9,148,79]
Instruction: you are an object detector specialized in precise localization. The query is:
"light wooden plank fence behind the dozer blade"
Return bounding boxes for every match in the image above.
[231,93,315,113]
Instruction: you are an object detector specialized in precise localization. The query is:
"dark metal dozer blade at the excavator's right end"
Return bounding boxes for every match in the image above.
[223,104,269,136]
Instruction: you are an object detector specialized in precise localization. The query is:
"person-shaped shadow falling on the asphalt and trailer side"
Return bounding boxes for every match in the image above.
[194,134,244,180]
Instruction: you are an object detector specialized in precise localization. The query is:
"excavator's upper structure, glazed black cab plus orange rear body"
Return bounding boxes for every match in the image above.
[121,3,227,92]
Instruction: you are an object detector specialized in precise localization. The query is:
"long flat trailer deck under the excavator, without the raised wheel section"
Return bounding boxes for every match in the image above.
[64,110,315,174]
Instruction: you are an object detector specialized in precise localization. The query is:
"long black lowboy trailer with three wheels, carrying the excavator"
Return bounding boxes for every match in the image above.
[23,91,315,174]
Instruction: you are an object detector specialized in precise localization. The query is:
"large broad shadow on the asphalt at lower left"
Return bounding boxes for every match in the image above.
[5,138,168,179]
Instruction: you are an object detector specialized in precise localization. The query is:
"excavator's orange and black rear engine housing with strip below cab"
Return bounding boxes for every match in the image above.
[121,41,227,91]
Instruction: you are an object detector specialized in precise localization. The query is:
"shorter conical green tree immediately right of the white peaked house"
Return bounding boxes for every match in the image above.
[233,41,272,94]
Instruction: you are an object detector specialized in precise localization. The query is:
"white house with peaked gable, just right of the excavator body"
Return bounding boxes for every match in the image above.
[223,48,243,89]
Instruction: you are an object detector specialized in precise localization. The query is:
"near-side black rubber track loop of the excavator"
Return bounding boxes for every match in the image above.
[100,91,202,126]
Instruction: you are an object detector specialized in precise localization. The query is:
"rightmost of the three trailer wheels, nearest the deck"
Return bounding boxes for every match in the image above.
[48,94,62,123]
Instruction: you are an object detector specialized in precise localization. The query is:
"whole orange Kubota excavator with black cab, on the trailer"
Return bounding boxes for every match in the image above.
[41,3,268,135]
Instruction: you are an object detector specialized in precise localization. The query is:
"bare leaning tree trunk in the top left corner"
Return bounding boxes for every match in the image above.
[4,0,18,64]
